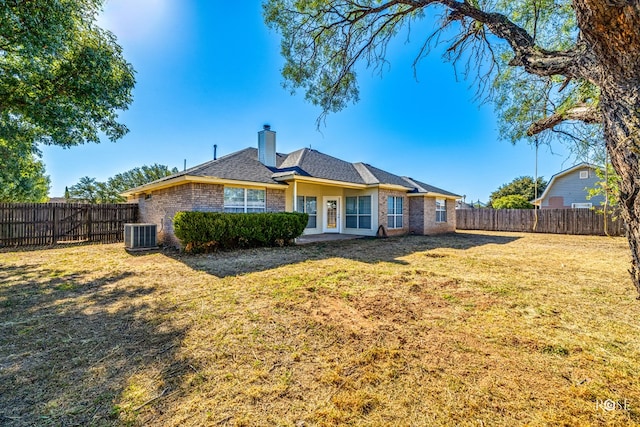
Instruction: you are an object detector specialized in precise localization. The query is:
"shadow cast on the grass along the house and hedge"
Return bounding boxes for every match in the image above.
[167,233,519,278]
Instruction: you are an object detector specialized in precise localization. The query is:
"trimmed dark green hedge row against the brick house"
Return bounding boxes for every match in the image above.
[173,212,309,253]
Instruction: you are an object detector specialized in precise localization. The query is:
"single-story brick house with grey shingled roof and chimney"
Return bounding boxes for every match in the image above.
[123,125,460,245]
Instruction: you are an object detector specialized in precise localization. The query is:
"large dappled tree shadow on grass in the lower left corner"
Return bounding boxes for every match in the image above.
[0,264,189,426]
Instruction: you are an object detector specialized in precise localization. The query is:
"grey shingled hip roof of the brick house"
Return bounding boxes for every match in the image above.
[124,148,460,197]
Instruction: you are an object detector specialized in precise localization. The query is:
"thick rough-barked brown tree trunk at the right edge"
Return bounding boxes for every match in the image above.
[573,0,640,299]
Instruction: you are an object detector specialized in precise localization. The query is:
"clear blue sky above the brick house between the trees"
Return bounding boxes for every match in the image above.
[42,0,575,201]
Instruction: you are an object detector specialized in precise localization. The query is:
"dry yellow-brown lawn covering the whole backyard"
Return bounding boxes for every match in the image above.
[0,232,640,426]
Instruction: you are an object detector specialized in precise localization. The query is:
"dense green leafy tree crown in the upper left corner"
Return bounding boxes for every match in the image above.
[0,0,135,200]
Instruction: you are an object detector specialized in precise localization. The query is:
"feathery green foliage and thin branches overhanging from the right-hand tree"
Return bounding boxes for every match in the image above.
[263,0,602,151]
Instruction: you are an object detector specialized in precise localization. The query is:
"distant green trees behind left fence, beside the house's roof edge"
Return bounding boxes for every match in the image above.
[65,163,178,203]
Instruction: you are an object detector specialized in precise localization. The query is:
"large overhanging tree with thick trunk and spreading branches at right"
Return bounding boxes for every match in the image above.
[264,0,640,298]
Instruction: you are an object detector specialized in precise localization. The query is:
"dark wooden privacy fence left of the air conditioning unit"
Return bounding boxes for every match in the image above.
[0,203,138,247]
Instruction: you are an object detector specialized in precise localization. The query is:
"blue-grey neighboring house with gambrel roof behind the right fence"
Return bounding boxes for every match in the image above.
[531,163,604,209]
